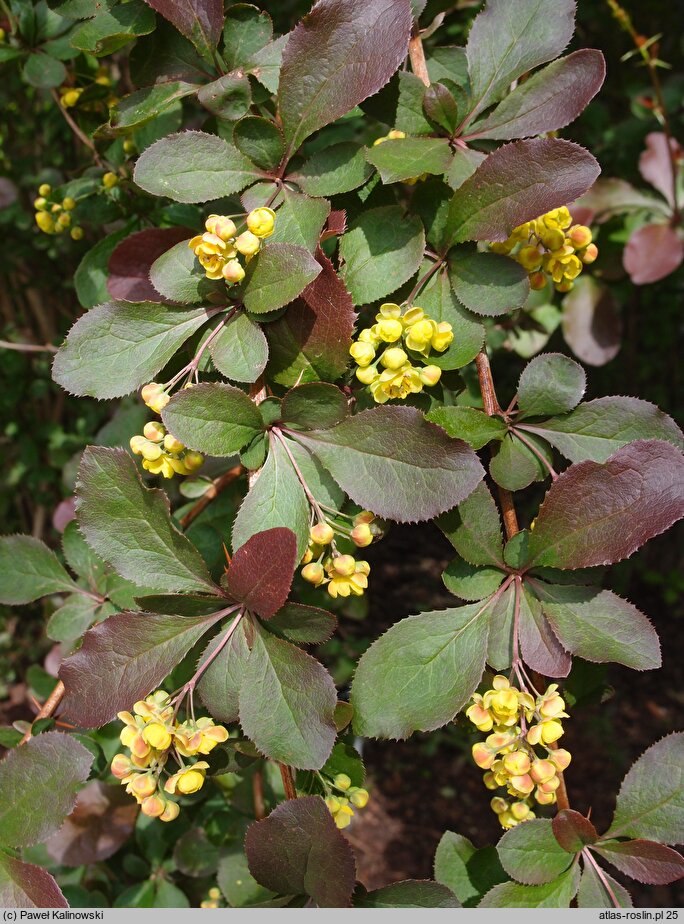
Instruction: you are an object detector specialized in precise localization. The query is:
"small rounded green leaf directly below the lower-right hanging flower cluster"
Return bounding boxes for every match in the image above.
[496,818,573,885]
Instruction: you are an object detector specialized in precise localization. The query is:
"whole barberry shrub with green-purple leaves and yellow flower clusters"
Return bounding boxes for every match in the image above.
[0,0,684,907]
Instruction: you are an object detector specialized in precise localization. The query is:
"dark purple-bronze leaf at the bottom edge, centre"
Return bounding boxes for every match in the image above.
[245,796,356,908]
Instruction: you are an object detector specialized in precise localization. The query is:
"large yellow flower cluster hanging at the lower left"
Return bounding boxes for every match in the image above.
[111,690,228,821]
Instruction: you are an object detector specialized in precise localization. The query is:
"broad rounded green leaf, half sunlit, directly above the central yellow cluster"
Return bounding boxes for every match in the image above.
[340,205,425,305]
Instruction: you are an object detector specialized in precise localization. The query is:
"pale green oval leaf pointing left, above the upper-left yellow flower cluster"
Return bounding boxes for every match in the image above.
[133,131,261,202]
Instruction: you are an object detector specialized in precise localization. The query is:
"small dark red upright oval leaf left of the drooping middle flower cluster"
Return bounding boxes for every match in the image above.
[227,526,297,619]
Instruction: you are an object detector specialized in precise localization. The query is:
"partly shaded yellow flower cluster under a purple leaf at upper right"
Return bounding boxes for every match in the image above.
[489,206,598,292]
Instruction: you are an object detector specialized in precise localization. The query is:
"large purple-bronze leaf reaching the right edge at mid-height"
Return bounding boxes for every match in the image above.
[529,440,684,570]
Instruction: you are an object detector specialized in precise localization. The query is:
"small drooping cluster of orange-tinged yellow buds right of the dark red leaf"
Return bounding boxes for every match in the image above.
[301,510,382,597]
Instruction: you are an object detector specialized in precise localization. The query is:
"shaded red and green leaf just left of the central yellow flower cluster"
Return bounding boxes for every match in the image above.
[266,250,356,385]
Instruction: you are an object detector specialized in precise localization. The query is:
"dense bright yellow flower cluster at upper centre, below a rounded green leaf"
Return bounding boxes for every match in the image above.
[349,302,454,404]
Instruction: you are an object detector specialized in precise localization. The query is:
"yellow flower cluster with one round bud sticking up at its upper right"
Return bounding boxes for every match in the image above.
[188,206,276,286]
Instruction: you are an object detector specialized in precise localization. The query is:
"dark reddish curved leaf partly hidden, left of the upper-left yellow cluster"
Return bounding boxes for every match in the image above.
[107,228,192,302]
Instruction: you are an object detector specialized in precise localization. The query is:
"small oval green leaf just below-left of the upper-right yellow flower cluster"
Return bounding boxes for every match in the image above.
[449,251,530,317]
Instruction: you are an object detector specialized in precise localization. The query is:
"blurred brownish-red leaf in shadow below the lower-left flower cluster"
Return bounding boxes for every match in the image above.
[47,780,138,866]
